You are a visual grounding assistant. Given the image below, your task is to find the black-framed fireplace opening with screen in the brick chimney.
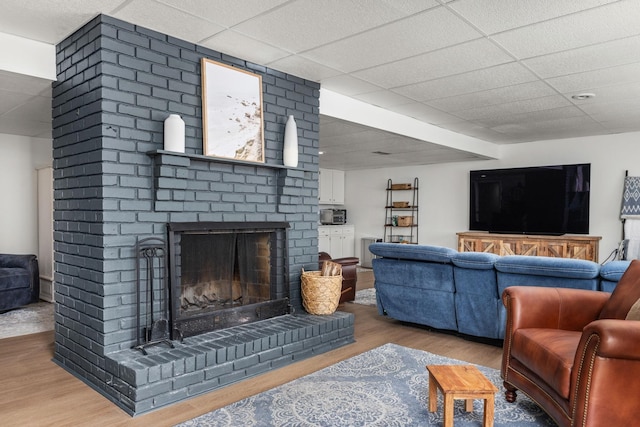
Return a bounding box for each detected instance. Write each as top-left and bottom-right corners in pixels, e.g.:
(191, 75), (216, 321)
(168, 222), (289, 339)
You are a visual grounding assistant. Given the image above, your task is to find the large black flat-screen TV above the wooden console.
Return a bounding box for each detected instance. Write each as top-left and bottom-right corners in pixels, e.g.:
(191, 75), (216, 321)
(469, 164), (591, 235)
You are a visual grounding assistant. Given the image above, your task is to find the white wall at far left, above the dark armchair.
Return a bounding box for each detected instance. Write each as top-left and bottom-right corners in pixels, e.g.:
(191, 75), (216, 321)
(0, 134), (52, 254)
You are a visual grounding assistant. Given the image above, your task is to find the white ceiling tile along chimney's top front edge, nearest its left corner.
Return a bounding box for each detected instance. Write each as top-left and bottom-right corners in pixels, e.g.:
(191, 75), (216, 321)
(113, 0), (224, 43)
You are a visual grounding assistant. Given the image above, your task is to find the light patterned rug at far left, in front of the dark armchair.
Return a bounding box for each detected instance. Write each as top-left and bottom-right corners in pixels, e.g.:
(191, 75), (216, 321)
(0, 301), (54, 338)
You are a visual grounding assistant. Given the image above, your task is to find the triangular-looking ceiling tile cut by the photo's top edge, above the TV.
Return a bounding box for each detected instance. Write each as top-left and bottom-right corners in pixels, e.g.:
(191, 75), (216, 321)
(451, 0), (617, 34)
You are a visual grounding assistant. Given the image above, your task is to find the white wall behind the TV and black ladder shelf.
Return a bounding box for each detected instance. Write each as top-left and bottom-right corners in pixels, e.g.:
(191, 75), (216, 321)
(345, 132), (640, 262)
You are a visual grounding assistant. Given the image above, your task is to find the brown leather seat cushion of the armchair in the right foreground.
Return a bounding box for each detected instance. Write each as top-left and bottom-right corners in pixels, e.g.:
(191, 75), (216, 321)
(511, 328), (582, 399)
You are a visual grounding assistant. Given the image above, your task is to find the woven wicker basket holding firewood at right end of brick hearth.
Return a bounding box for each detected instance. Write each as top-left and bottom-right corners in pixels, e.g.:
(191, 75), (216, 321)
(300, 271), (342, 314)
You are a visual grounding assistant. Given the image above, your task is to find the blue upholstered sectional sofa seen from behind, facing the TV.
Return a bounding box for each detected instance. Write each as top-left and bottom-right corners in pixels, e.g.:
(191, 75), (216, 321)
(369, 243), (629, 339)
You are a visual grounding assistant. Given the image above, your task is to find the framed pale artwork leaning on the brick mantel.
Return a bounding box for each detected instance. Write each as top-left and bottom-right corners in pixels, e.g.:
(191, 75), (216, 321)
(201, 58), (264, 163)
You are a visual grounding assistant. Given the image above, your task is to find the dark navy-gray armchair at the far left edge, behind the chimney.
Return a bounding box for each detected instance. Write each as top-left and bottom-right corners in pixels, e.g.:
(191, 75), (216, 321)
(0, 254), (40, 312)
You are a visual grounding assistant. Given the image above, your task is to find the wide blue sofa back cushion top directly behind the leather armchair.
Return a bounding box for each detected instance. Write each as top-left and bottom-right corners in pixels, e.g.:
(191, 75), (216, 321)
(495, 255), (600, 279)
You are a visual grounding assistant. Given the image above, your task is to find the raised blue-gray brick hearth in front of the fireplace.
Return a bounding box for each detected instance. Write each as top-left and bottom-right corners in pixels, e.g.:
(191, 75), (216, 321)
(107, 312), (354, 413)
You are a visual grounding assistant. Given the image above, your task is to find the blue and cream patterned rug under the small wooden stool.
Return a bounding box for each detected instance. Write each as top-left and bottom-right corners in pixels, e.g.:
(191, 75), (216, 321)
(179, 344), (555, 427)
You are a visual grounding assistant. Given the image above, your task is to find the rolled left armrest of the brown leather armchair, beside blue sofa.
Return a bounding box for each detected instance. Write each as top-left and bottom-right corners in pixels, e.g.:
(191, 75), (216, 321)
(502, 286), (610, 334)
